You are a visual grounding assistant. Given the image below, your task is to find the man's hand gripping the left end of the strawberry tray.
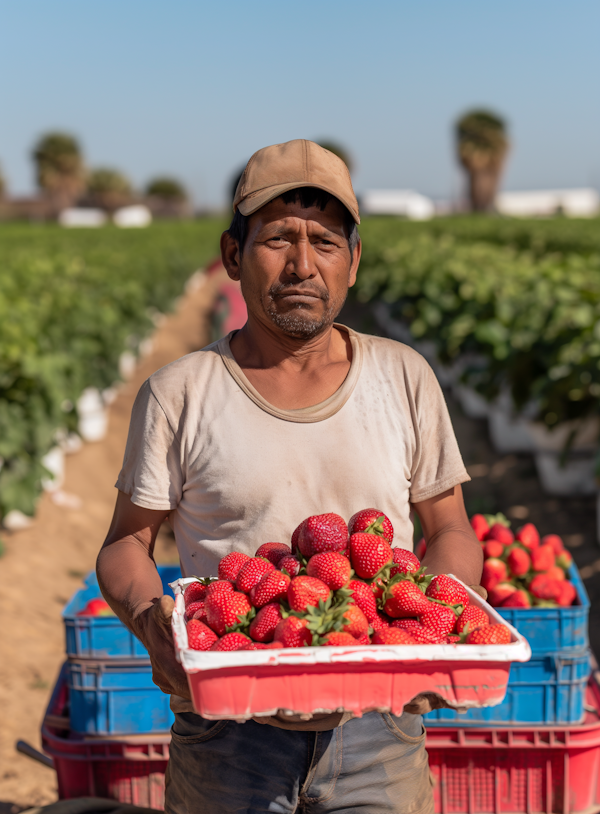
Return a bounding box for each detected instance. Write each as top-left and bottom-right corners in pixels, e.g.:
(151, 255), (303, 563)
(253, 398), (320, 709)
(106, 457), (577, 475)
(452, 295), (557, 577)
(136, 596), (191, 700)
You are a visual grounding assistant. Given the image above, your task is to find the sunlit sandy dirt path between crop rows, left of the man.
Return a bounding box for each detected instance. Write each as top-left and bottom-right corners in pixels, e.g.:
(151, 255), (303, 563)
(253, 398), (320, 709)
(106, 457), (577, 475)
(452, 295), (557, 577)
(0, 275), (219, 814)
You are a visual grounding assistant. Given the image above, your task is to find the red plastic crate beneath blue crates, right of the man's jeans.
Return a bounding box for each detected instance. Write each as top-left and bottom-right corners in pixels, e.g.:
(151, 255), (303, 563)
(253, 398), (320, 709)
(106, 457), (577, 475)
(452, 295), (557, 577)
(427, 679), (600, 814)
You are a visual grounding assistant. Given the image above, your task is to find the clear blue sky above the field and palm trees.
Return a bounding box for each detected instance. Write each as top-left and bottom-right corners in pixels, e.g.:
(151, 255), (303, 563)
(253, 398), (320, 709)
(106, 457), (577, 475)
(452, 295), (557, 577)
(0, 0), (600, 206)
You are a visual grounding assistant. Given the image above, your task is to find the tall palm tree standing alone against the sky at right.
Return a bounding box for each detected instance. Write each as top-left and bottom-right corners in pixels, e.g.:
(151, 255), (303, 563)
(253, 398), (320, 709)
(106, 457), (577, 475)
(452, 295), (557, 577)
(456, 110), (510, 212)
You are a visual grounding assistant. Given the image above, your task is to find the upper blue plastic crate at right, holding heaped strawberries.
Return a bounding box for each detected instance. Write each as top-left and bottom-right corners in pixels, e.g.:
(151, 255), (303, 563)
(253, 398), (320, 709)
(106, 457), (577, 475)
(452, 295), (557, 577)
(496, 564), (590, 653)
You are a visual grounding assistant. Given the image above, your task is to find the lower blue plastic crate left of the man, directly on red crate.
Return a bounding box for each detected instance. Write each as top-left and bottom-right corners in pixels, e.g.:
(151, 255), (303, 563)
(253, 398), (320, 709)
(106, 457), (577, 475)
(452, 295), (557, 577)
(68, 659), (174, 735)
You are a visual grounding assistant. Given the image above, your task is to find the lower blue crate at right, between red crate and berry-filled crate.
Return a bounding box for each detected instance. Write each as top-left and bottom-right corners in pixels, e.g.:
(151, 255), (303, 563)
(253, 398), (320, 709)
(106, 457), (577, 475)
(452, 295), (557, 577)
(424, 648), (591, 726)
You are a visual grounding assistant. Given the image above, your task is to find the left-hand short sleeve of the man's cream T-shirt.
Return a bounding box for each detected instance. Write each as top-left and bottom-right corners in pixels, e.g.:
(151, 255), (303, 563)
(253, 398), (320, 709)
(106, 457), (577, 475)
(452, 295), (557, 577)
(115, 381), (183, 510)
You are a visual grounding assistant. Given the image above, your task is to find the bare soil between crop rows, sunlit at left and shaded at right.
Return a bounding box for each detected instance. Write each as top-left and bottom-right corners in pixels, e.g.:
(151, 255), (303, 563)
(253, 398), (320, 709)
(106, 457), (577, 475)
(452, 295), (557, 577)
(0, 288), (600, 814)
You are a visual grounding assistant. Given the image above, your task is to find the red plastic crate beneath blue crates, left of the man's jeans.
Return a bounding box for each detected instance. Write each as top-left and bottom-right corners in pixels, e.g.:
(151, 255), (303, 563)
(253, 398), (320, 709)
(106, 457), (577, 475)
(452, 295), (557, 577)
(42, 667), (171, 810)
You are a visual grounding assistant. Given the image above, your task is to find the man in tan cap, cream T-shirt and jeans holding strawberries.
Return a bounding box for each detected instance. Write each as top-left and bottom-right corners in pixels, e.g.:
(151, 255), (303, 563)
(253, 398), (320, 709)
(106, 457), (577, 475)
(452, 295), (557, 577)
(98, 140), (482, 814)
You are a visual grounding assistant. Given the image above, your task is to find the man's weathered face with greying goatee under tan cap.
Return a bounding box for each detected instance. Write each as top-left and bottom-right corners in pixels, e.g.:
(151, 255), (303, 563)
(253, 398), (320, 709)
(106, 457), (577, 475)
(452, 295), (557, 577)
(223, 198), (360, 339)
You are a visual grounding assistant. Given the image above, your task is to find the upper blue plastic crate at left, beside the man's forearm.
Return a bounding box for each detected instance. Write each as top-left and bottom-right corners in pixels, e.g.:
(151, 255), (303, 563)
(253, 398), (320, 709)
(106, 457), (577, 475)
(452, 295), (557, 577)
(62, 565), (181, 660)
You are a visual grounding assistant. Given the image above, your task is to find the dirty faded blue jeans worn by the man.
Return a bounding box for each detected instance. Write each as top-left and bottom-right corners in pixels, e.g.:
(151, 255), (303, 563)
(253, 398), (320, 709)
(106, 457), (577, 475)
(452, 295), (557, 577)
(165, 712), (433, 814)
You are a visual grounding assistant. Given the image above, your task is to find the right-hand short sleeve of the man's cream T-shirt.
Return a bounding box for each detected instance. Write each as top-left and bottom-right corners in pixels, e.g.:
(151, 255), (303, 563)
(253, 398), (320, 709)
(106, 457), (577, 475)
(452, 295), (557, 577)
(410, 365), (471, 503)
